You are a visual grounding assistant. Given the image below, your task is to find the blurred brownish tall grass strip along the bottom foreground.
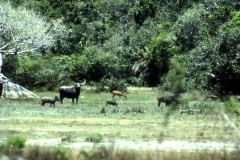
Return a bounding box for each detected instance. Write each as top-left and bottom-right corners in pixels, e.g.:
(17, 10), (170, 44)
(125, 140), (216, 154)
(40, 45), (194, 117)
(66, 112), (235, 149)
(0, 144), (239, 160)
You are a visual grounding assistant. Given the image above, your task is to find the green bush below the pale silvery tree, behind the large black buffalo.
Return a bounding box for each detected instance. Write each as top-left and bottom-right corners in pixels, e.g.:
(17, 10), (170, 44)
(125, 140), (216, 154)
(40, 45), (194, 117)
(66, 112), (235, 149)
(3, 53), (71, 91)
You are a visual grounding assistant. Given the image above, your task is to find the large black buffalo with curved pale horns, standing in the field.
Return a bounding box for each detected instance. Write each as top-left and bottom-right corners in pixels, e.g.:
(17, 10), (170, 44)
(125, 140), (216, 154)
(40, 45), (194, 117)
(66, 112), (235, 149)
(59, 79), (86, 104)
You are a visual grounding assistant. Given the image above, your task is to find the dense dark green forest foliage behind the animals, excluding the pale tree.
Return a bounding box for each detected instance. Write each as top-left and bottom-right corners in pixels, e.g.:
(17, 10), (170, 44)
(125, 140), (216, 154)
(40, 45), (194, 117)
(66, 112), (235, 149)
(2, 0), (240, 93)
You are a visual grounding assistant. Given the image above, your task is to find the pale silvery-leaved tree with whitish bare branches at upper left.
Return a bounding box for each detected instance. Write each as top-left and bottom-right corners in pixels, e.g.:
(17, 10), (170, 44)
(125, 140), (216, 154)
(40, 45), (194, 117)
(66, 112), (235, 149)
(0, 2), (67, 72)
